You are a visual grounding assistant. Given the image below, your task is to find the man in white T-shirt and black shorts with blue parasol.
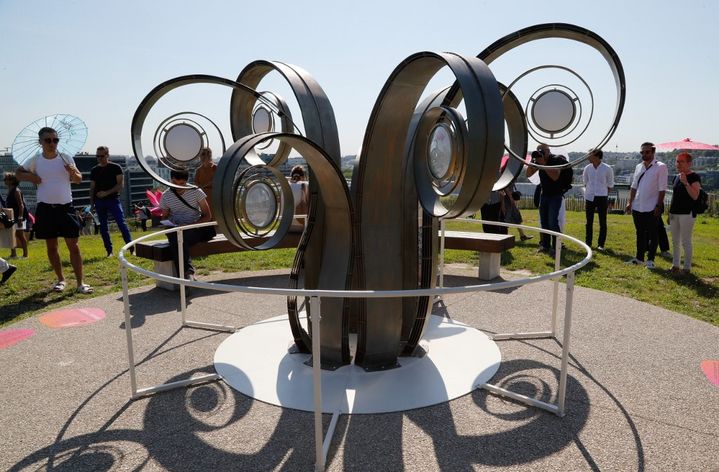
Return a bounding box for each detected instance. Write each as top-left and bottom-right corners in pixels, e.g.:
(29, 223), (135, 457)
(15, 127), (93, 294)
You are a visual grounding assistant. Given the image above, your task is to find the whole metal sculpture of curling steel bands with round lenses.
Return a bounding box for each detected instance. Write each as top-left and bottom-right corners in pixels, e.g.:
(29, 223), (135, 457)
(132, 23), (625, 370)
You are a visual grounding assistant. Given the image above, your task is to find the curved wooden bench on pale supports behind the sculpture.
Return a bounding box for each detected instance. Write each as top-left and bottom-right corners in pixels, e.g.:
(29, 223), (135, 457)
(135, 231), (515, 290)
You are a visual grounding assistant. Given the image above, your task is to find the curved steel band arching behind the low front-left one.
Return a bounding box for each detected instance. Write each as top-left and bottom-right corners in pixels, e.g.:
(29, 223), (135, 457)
(230, 60), (349, 363)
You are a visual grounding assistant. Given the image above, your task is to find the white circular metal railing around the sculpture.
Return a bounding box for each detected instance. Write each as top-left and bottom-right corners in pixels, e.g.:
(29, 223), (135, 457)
(118, 218), (592, 471)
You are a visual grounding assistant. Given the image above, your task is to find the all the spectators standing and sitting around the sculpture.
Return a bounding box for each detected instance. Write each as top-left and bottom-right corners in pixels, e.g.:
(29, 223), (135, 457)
(0, 127), (701, 294)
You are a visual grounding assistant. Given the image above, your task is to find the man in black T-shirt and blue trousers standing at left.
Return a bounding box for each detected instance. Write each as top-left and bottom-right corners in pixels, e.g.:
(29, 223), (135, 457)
(90, 146), (132, 257)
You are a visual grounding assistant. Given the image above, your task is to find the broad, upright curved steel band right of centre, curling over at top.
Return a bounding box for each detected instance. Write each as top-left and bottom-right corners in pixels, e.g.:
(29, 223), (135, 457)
(353, 52), (504, 369)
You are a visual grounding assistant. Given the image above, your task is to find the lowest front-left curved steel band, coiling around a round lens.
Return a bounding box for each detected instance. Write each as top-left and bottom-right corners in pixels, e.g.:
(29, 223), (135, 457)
(212, 133), (353, 368)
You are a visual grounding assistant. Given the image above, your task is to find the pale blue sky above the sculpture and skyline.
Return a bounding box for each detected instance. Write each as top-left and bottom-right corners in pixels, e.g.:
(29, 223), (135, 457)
(0, 0), (719, 155)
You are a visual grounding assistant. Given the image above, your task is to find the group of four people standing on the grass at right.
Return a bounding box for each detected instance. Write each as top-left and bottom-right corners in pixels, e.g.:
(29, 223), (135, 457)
(527, 142), (701, 274)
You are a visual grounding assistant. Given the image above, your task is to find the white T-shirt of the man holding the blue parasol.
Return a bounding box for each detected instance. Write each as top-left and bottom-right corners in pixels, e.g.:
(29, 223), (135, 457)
(23, 153), (75, 205)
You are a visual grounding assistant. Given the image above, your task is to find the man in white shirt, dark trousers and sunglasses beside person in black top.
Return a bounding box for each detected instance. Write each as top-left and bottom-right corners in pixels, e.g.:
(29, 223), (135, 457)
(625, 142), (669, 269)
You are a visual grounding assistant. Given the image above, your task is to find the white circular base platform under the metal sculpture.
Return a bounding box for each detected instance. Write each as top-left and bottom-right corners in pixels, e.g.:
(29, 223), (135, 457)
(215, 315), (501, 413)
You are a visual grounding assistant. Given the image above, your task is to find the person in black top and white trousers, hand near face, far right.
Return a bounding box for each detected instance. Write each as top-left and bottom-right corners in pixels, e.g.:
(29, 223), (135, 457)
(669, 152), (702, 274)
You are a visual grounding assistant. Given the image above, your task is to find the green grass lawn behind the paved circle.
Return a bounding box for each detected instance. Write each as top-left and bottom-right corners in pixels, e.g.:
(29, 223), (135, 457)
(0, 210), (719, 326)
